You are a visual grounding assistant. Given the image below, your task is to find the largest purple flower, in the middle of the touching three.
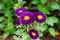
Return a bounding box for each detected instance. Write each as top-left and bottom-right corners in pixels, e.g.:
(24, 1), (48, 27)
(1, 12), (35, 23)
(19, 12), (34, 25)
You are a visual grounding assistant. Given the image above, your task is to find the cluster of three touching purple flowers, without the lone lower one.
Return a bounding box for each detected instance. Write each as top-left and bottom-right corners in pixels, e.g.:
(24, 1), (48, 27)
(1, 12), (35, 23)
(15, 8), (46, 25)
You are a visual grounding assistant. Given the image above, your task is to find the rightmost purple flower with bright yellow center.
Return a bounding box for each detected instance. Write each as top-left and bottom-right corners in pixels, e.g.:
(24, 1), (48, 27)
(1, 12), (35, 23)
(34, 12), (46, 23)
